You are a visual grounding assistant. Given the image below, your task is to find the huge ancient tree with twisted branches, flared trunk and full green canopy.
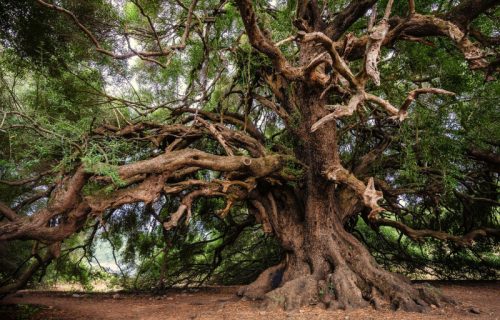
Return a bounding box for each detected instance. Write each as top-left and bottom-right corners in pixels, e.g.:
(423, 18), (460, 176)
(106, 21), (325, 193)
(0, 0), (500, 310)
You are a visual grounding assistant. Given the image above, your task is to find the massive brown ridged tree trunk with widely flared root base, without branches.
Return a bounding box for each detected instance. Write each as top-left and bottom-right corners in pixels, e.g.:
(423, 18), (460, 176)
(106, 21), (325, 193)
(239, 82), (452, 311)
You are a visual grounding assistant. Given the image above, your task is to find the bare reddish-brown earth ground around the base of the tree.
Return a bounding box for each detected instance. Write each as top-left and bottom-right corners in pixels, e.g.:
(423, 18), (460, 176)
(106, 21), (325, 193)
(0, 281), (500, 320)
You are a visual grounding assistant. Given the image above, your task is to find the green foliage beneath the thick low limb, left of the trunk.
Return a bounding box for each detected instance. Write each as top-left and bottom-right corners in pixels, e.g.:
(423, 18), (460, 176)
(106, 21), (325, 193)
(81, 199), (281, 290)
